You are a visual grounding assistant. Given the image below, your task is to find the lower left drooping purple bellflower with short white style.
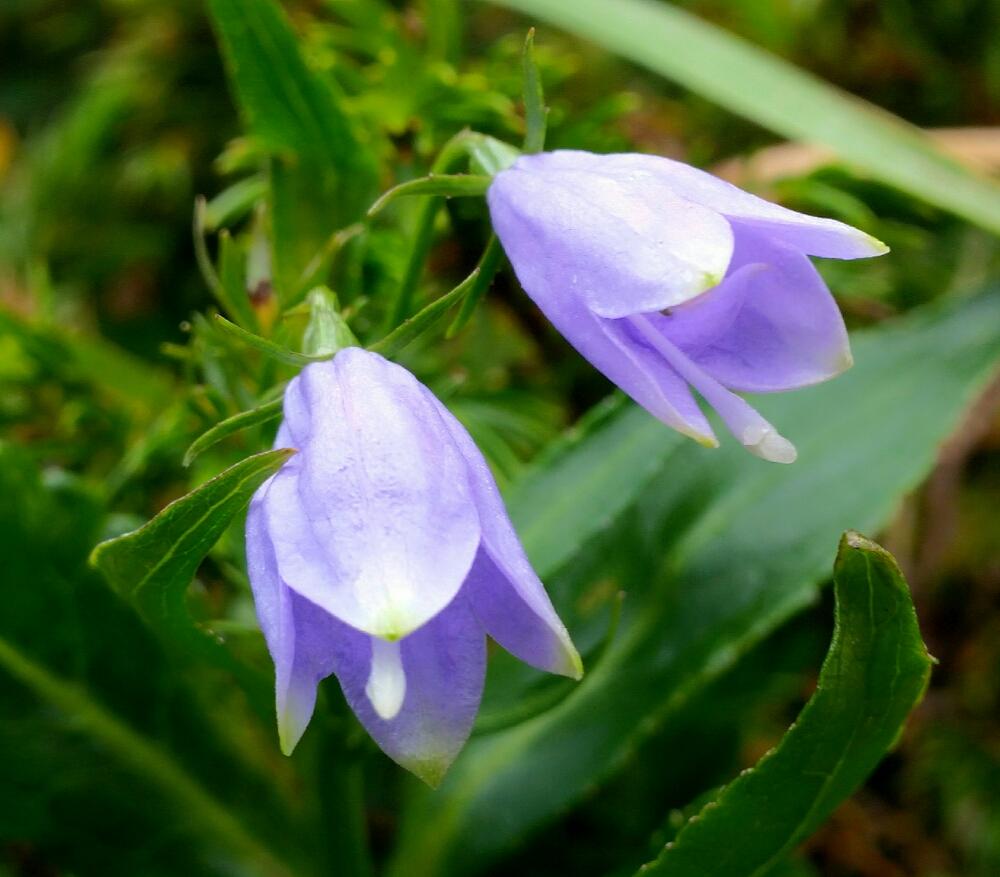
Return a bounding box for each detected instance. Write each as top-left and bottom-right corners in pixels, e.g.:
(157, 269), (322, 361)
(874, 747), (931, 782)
(246, 348), (582, 784)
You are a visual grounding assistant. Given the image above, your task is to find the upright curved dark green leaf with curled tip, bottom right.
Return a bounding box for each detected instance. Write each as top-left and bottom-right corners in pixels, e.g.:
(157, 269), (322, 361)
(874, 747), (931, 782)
(639, 533), (931, 877)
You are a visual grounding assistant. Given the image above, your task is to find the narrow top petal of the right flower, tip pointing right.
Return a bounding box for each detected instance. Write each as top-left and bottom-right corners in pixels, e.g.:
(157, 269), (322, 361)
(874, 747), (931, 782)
(528, 150), (888, 258)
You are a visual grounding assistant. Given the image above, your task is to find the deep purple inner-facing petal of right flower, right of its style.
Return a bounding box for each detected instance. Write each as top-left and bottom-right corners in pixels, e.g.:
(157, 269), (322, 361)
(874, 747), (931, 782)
(648, 224), (851, 393)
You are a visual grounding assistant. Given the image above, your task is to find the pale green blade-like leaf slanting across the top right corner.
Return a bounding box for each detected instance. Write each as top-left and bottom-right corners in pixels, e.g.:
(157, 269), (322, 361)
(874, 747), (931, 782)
(491, 0), (1000, 233)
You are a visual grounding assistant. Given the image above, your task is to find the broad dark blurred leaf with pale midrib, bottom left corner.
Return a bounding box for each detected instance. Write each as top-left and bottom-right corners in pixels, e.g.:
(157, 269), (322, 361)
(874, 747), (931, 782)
(0, 441), (309, 877)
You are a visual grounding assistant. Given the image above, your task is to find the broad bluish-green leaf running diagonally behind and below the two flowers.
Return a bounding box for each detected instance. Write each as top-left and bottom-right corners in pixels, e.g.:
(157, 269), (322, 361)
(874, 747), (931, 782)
(394, 292), (1000, 875)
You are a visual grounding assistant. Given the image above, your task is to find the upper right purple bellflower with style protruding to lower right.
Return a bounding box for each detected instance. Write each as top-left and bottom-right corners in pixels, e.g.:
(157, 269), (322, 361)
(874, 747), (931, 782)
(487, 151), (887, 463)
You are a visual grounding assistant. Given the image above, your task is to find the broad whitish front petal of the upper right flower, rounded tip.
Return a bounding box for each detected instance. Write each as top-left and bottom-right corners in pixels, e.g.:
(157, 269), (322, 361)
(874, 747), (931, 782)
(487, 153), (733, 317)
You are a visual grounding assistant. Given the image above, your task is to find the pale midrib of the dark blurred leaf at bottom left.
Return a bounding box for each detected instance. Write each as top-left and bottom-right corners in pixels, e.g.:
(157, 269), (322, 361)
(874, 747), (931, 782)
(0, 638), (292, 877)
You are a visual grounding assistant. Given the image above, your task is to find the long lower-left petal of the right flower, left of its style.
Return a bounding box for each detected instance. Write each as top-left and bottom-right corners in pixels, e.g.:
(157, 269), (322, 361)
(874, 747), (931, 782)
(491, 183), (717, 446)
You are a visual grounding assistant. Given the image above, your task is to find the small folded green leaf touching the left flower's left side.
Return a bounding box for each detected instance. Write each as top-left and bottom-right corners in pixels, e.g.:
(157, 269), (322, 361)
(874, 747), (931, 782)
(90, 450), (295, 639)
